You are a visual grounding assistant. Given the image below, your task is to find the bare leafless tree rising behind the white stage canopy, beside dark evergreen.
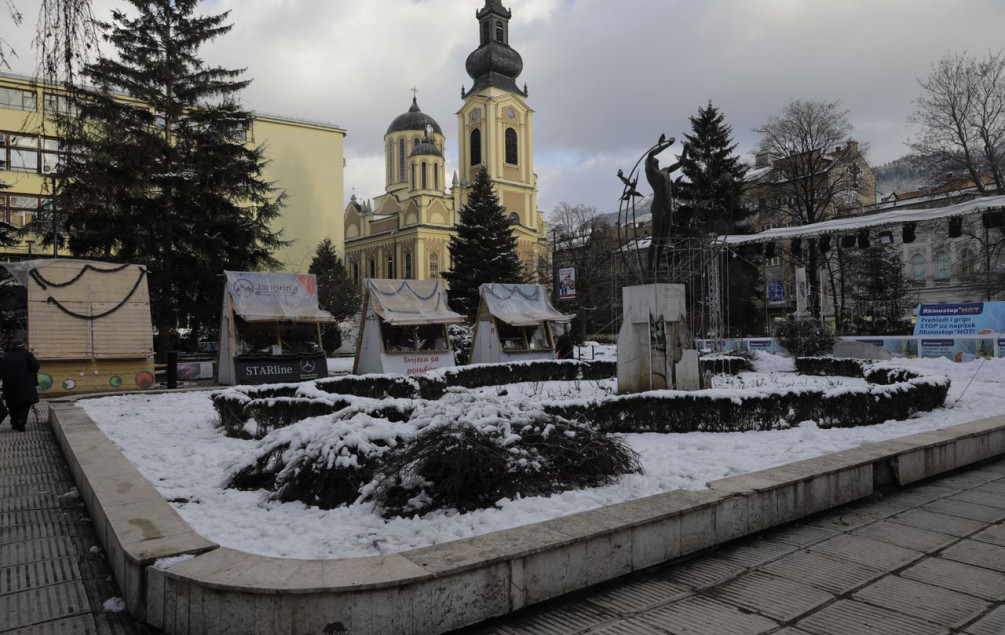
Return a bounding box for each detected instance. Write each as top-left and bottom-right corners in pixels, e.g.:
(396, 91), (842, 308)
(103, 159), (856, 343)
(754, 99), (862, 318)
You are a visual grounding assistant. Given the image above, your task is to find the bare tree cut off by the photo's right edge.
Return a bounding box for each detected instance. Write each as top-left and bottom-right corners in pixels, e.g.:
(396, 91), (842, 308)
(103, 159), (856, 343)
(908, 51), (1005, 194)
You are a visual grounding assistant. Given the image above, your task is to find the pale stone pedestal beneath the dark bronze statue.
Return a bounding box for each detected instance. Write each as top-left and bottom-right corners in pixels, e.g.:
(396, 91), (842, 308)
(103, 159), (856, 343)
(618, 283), (701, 394)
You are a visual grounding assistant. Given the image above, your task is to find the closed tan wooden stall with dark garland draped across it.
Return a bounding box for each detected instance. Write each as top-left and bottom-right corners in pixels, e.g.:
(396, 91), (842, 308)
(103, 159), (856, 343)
(0, 258), (154, 396)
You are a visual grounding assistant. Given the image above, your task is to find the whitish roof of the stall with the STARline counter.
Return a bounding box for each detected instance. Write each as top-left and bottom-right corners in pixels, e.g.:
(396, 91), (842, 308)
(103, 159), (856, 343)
(224, 271), (335, 322)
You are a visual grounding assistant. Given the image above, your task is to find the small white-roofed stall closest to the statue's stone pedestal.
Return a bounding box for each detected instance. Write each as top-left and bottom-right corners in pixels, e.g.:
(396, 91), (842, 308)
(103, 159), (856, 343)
(471, 284), (575, 364)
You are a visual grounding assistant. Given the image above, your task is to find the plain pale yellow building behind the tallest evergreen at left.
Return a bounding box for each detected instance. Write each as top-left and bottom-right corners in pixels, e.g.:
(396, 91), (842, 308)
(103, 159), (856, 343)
(0, 73), (346, 271)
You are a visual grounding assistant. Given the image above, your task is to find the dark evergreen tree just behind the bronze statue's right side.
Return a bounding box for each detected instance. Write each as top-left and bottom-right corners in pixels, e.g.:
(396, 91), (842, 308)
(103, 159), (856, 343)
(677, 101), (747, 234)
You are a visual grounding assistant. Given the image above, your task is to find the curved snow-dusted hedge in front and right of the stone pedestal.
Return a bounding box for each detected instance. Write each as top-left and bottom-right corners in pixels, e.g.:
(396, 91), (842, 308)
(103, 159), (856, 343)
(546, 360), (950, 433)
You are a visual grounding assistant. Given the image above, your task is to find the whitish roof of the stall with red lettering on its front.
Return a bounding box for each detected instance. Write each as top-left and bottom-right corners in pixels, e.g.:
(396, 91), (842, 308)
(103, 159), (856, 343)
(366, 278), (464, 326)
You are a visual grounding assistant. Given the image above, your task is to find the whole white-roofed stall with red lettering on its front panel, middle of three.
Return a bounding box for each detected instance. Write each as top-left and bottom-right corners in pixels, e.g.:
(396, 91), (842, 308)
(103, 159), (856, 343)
(353, 279), (464, 375)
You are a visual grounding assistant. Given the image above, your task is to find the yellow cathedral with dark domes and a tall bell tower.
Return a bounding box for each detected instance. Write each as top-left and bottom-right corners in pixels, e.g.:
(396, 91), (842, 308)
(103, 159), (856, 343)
(345, 0), (548, 285)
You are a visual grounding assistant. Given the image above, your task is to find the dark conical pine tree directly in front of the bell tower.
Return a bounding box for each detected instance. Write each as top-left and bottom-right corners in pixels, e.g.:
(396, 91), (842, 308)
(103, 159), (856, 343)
(443, 170), (524, 320)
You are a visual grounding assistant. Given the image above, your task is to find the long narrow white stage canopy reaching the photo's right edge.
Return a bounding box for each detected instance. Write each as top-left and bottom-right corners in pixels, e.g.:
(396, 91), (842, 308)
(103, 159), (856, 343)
(725, 196), (1005, 245)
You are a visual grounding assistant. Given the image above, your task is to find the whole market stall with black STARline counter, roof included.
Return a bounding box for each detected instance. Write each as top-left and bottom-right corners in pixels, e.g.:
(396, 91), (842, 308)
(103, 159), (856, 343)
(217, 271), (335, 385)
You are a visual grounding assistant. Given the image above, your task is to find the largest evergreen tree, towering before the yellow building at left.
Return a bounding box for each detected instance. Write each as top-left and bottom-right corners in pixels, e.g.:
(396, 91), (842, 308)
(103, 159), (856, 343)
(56, 0), (286, 355)
